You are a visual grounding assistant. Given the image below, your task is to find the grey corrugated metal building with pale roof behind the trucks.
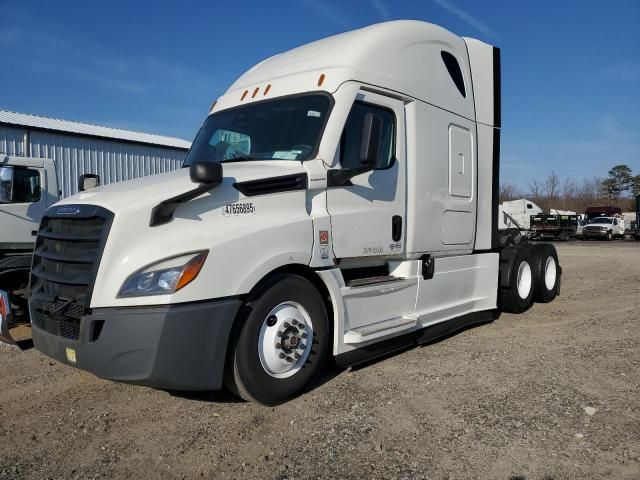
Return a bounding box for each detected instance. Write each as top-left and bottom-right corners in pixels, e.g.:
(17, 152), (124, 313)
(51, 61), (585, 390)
(0, 110), (191, 197)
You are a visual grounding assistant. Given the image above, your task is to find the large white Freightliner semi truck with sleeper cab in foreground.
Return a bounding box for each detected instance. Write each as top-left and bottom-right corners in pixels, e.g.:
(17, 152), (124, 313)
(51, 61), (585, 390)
(30, 21), (561, 405)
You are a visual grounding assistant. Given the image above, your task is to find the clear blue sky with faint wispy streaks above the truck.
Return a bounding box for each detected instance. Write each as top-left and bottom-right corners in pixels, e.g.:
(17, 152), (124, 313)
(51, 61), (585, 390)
(0, 0), (640, 189)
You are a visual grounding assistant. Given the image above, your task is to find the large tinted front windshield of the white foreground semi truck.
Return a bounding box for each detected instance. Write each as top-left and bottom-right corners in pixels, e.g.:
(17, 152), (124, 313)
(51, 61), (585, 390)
(184, 93), (331, 166)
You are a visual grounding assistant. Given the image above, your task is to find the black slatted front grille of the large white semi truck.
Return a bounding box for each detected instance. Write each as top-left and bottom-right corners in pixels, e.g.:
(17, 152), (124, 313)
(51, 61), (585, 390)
(29, 205), (113, 340)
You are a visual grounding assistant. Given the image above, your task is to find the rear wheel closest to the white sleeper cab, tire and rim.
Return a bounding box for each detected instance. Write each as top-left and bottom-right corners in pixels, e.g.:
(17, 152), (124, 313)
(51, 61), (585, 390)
(498, 245), (535, 313)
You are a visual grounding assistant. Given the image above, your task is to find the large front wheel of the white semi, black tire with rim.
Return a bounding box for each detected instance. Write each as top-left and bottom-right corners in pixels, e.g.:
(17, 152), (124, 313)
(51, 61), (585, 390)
(225, 274), (329, 405)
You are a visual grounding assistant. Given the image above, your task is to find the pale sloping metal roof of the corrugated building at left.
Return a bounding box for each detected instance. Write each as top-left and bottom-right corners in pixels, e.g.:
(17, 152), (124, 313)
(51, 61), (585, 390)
(0, 110), (191, 150)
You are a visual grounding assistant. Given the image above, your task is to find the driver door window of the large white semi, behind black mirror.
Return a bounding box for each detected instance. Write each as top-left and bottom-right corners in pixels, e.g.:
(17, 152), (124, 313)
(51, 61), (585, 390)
(340, 102), (395, 170)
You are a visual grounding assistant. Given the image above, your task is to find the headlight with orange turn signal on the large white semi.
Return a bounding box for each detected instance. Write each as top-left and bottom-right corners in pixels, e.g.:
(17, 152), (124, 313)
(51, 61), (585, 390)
(118, 252), (208, 297)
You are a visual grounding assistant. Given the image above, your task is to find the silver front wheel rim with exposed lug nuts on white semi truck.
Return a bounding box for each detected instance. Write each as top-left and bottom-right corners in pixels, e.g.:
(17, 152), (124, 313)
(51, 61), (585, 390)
(258, 301), (313, 378)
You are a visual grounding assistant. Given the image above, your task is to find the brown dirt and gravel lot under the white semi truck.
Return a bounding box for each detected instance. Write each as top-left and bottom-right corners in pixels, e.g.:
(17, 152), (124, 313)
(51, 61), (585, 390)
(0, 242), (640, 480)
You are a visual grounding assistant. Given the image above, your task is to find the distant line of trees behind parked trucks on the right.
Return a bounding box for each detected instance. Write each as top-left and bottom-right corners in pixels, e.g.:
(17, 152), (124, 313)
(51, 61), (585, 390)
(500, 165), (640, 213)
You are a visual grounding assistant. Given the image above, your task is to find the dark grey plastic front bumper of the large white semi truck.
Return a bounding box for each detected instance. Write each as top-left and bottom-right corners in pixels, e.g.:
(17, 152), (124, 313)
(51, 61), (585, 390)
(32, 298), (241, 390)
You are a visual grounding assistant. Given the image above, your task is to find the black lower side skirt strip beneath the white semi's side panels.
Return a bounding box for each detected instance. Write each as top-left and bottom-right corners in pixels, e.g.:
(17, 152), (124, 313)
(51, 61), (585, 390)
(335, 310), (499, 367)
